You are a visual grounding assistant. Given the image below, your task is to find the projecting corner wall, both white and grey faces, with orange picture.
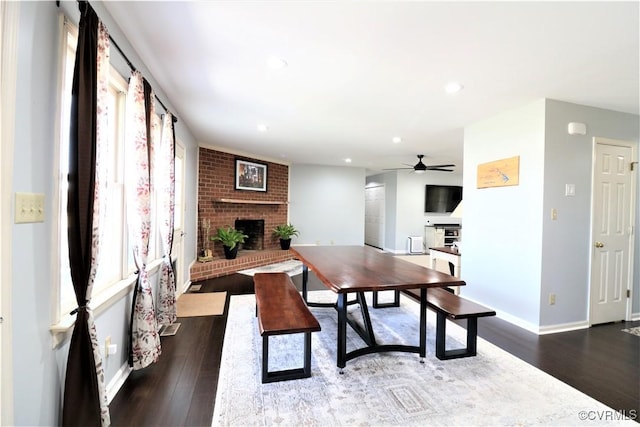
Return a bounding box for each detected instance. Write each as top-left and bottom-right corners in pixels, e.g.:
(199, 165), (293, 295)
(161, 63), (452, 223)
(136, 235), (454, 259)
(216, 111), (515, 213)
(462, 100), (640, 332)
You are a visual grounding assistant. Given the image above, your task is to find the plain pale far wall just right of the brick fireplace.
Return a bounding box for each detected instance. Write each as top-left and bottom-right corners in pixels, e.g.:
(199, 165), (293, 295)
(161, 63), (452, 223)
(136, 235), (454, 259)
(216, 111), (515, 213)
(289, 164), (365, 245)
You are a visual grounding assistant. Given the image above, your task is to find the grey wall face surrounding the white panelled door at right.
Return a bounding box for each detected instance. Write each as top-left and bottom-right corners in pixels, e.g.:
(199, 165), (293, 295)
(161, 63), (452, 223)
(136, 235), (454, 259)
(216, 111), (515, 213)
(540, 100), (640, 326)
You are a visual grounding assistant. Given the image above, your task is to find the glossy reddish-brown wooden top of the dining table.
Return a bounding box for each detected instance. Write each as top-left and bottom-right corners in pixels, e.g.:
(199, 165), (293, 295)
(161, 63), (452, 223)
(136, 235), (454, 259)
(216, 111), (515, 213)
(291, 246), (465, 293)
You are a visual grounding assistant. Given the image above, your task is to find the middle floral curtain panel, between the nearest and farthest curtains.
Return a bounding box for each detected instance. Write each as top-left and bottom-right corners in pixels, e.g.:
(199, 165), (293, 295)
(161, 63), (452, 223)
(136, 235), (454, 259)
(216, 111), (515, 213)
(125, 71), (161, 369)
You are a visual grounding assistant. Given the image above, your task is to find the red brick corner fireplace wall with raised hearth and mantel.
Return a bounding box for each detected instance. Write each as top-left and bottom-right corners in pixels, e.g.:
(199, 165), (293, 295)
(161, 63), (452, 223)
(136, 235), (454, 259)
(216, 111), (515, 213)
(191, 147), (292, 281)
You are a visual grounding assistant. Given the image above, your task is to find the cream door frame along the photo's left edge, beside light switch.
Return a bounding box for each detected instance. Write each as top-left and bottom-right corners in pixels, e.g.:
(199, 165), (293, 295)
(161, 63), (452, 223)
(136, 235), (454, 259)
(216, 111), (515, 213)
(0, 2), (20, 425)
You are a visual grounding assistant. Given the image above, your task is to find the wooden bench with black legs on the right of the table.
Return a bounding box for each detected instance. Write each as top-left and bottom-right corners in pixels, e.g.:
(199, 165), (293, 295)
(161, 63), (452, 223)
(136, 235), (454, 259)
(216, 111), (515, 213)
(405, 288), (496, 360)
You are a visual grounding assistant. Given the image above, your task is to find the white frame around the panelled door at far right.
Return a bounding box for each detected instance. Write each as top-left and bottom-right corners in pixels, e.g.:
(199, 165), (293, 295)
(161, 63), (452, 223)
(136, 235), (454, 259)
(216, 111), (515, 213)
(588, 137), (638, 326)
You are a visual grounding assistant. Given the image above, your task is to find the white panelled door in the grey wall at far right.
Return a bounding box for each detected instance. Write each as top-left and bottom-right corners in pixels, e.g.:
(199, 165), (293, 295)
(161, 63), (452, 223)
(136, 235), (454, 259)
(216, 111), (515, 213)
(589, 138), (634, 325)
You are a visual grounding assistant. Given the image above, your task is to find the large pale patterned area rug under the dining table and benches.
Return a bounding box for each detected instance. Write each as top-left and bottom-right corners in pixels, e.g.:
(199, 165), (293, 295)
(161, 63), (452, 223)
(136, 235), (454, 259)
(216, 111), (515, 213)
(212, 291), (636, 426)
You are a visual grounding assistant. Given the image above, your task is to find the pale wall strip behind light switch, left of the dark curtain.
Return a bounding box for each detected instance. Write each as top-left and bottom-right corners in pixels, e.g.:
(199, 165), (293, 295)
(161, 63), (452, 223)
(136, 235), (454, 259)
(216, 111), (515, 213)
(11, 2), (62, 425)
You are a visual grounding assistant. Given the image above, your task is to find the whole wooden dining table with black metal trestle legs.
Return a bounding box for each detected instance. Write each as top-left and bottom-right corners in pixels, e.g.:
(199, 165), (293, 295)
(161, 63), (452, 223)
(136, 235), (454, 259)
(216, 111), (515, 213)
(290, 246), (465, 373)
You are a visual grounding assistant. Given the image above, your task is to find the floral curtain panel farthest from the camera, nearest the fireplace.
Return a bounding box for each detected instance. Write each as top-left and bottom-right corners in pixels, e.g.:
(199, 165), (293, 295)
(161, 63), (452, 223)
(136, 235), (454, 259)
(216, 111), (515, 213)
(156, 111), (177, 325)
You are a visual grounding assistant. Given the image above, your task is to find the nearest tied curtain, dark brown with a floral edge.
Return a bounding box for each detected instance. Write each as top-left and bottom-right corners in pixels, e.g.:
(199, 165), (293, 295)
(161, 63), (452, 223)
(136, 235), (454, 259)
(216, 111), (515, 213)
(62, 2), (111, 426)
